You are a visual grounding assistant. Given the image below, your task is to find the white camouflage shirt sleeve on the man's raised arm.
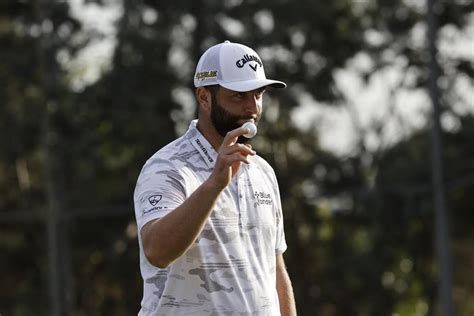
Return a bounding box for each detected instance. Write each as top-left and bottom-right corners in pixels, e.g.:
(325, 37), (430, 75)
(134, 159), (186, 231)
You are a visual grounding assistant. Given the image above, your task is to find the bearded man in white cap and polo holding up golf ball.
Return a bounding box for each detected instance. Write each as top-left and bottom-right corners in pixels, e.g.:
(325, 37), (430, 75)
(134, 41), (296, 316)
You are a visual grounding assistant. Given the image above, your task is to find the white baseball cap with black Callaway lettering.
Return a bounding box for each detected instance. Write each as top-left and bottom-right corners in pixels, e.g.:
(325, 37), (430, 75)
(194, 41), (286, 92)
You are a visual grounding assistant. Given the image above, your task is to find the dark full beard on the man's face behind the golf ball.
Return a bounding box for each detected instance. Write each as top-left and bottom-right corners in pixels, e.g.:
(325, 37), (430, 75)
(211, 95), (258, 144)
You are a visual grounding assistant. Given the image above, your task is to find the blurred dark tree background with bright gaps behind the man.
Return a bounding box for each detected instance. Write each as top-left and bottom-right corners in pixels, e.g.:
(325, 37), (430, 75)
(0, 0), (474, 316)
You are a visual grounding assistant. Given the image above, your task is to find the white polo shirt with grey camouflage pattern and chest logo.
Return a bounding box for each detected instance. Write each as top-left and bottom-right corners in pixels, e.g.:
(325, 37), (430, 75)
(134, 120), (287, 316)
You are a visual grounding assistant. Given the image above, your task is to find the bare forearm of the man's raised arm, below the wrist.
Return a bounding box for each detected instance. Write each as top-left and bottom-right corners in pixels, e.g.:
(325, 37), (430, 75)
(141, 181), (221, 268)
